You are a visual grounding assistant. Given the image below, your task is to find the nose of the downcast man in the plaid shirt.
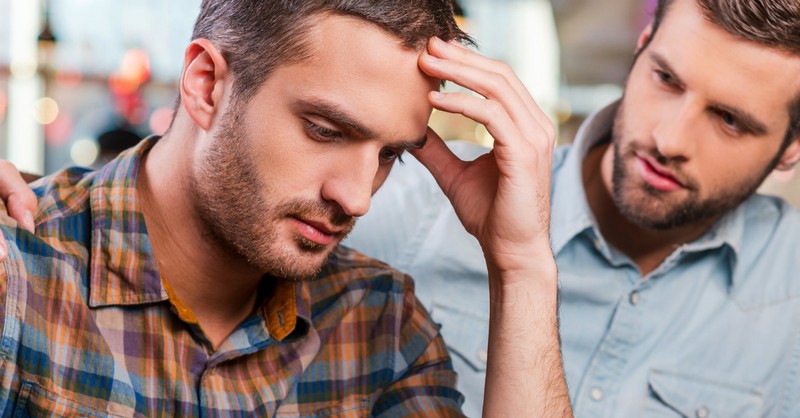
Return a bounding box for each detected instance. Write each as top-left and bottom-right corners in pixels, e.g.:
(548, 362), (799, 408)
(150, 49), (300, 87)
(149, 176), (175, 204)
(322, 147), (380, 217)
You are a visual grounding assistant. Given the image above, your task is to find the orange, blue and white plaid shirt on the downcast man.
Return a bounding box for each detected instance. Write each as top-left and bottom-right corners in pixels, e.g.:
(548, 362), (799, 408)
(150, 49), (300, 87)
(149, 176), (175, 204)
(0, 138), (462, 417)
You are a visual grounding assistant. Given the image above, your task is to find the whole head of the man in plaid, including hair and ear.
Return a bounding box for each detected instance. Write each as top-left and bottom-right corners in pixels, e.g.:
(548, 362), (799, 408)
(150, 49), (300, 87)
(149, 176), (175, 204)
(176, 0), (466, 279)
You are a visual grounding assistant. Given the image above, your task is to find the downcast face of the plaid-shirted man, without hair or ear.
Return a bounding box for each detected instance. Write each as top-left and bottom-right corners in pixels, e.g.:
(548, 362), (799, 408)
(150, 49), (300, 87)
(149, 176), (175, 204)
(192, 16), (438, 279)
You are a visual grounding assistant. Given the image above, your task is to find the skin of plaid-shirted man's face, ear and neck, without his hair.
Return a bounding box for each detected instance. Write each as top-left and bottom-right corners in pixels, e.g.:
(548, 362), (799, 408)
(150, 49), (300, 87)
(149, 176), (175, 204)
(139, 17), (438, 346)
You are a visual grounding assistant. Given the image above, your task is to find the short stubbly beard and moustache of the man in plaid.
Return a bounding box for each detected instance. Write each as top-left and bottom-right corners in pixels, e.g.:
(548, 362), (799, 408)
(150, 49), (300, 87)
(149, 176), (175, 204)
(189, 105), (355, 281)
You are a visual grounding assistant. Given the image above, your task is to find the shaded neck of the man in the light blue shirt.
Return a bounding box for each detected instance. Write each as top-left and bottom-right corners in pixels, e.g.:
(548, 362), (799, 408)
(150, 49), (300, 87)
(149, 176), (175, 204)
(583, 145), (716, 277)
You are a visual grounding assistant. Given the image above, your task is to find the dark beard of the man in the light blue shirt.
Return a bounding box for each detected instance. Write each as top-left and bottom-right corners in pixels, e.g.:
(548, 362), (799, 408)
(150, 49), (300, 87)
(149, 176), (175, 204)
(611, 99), (783, 231)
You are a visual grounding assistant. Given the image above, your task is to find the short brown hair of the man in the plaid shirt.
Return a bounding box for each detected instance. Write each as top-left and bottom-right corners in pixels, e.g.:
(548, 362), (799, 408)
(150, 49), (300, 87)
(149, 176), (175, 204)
(192, 0), (472, 102)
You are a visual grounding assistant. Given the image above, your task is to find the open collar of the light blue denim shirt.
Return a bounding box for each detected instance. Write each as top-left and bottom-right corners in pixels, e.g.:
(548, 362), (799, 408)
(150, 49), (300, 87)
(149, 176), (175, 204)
(550, 101), (746, 284)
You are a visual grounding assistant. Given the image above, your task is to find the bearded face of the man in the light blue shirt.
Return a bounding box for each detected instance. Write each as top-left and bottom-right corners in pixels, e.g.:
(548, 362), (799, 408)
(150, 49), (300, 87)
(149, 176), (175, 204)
(603, 0), (800, 230)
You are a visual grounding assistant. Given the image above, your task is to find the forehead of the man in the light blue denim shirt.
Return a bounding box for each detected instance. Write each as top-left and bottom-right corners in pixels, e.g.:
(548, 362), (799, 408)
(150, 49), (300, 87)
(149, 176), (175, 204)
(645, 0), (800, 124)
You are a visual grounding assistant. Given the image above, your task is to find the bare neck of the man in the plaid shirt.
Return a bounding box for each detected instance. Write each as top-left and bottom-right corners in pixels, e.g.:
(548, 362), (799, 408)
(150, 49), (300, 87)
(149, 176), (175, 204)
(137, 129), (262, 347)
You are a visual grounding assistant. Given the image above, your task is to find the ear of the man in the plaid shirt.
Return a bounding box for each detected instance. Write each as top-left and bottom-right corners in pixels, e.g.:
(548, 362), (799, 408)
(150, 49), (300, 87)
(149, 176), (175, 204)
(180, 39), (229, 131)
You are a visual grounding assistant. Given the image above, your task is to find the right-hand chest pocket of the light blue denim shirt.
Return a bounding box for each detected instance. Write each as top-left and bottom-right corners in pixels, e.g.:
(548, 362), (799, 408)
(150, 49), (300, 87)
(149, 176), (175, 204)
(642, 370), (763, 418)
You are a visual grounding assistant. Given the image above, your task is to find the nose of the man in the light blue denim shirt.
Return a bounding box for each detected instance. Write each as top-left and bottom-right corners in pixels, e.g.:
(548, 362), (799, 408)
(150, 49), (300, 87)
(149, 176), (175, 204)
(653, 100), (701, 160)
